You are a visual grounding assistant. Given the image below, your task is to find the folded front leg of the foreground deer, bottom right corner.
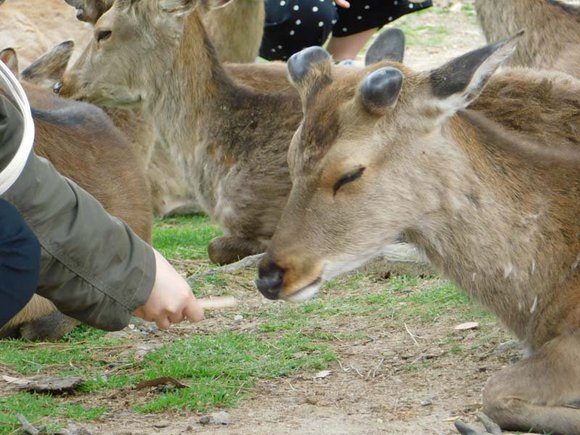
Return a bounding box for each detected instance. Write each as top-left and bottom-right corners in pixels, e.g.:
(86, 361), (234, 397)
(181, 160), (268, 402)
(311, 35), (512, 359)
(483, 331), (580, 435)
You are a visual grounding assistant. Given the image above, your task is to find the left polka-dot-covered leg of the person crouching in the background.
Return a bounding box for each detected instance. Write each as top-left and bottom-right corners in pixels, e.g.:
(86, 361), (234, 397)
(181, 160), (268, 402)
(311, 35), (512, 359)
(260, 0), (337, 60)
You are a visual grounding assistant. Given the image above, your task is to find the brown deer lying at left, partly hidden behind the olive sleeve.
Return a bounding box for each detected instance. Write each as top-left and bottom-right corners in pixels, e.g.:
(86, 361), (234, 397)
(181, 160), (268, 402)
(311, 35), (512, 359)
(0, 50), (152, 340)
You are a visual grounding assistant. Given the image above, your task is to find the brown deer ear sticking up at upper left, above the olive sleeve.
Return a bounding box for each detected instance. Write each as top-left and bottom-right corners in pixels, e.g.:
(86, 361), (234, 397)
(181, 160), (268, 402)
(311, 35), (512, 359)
(21, 41), (75, 83)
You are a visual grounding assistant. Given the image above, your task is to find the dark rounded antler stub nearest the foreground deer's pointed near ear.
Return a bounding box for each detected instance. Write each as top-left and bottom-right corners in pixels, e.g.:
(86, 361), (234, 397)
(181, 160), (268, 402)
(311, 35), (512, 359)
(358, 67), (403, 116)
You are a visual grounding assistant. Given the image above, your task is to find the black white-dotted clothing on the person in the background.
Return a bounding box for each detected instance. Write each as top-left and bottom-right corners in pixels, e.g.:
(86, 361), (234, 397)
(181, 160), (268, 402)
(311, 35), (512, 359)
(260, 0), (432, 60)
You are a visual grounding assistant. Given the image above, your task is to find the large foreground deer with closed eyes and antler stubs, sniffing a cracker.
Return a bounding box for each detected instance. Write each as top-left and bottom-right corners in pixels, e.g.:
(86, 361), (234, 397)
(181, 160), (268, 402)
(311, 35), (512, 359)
(256, 37), (580, 434)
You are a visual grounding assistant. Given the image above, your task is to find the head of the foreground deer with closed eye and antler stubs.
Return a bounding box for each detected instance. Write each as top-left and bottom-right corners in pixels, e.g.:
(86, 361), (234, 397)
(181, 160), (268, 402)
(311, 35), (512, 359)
(257, 33), (516, 302)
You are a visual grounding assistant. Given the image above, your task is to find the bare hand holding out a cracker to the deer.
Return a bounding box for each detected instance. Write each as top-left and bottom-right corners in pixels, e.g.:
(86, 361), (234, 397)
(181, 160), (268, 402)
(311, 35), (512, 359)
(134, 249), (203, 329)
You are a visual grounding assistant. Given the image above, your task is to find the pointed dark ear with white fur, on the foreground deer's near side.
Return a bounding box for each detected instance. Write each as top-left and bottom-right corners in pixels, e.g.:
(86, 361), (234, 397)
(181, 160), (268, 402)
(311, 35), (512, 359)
(429, 30), (524, 113)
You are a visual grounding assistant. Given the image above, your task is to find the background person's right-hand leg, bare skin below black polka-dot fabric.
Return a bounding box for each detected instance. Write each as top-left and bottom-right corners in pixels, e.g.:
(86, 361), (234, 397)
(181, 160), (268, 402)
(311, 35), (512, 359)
(328, 0), (432, 62)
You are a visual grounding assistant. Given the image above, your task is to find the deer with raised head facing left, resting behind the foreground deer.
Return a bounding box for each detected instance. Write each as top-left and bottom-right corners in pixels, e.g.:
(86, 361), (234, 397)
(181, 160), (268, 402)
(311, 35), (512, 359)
(56, 0), (404, 264)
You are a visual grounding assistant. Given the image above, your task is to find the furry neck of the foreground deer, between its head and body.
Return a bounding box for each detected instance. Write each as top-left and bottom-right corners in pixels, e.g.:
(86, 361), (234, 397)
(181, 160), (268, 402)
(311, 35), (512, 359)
(407, 114), (576, 343)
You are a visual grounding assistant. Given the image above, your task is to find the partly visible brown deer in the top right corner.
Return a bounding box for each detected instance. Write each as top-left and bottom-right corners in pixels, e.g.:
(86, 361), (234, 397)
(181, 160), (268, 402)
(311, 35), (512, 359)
(475, 0), (580, 78)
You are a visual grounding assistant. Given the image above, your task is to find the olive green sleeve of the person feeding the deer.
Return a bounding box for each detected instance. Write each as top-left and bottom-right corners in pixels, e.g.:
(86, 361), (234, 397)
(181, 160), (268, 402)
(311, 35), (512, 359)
(2, 153), (155, 330)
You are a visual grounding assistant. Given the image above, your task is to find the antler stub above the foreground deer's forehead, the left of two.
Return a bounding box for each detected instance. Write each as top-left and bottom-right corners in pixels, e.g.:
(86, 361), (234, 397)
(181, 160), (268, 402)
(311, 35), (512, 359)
(288, 47), (332, 102)
